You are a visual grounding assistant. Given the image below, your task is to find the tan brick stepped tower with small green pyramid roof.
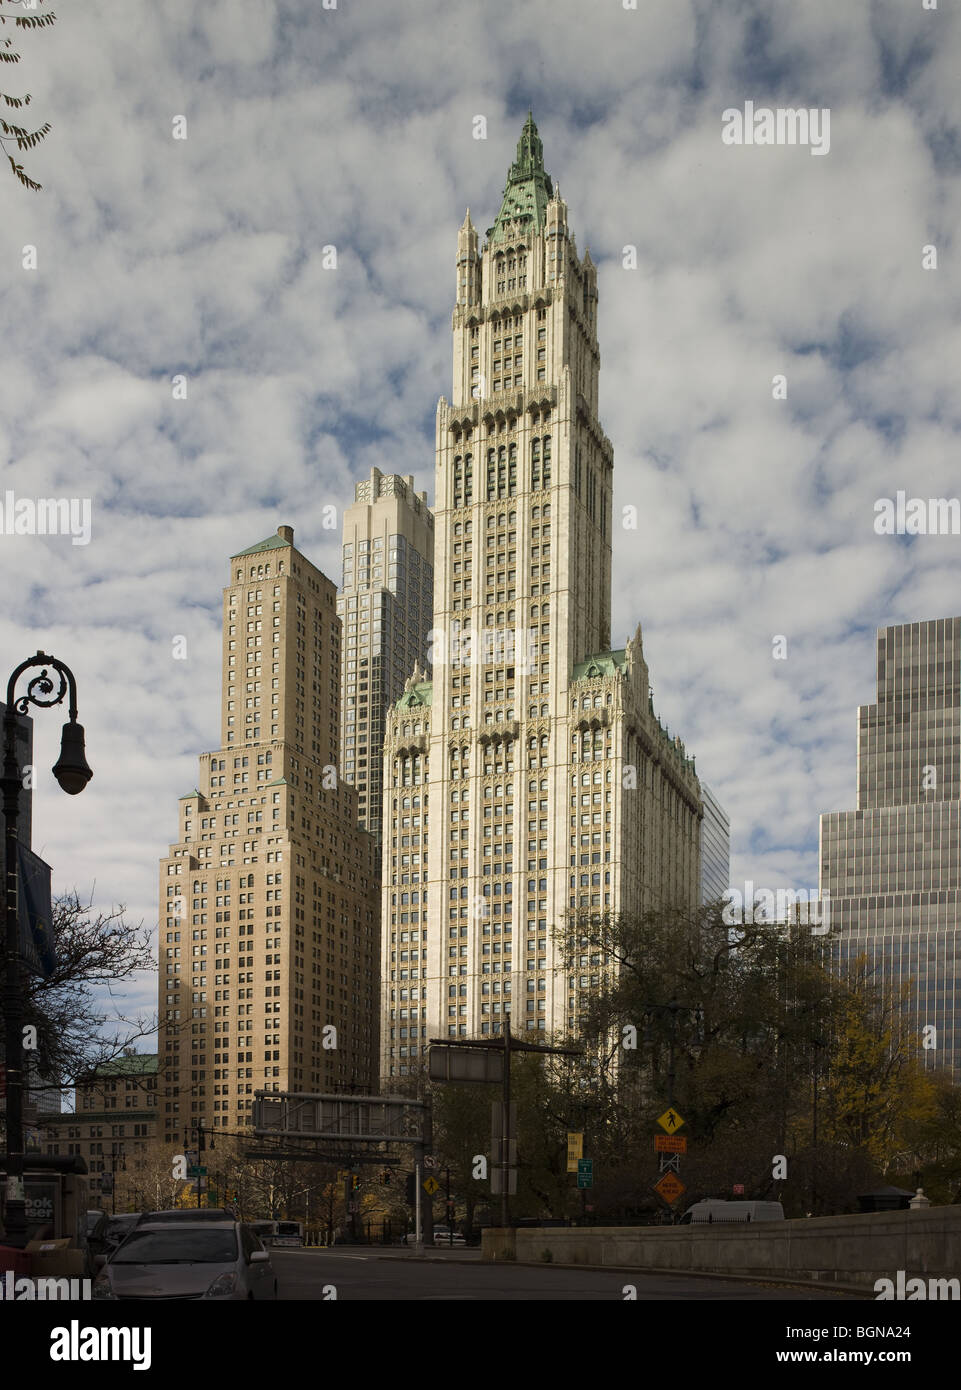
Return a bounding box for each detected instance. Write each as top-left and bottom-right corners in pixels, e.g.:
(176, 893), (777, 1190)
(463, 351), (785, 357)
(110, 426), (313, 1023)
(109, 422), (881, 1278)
(160, 525), (380, 1144)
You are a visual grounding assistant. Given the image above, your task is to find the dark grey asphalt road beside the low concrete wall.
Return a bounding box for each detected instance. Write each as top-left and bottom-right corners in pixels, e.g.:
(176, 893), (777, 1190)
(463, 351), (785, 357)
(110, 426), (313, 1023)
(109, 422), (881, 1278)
(270, 1247), (854, 1302)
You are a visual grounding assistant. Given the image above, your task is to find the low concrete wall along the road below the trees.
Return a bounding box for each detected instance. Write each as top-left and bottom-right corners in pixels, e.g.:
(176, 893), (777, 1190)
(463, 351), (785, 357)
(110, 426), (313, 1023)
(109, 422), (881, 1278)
(483, 1207), (961, 1291)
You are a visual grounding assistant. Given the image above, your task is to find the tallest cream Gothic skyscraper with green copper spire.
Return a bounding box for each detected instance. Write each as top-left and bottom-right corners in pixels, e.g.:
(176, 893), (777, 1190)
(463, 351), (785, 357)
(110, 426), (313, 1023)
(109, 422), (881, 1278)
(381, 115), (702, 1079)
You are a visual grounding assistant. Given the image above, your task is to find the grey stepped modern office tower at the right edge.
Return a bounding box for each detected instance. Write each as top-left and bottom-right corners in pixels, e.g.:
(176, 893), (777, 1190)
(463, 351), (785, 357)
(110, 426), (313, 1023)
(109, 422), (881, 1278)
(821, 617), (961, 1068)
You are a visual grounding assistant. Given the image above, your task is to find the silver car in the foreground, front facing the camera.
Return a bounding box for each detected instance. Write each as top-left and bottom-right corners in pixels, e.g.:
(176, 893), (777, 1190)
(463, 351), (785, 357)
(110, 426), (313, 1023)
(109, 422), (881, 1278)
(93, 1222), (277, 1300)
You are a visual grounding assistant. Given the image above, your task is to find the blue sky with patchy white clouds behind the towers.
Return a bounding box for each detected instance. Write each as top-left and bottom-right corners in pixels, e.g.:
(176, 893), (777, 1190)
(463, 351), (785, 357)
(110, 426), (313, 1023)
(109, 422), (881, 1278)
(0, 0), (961, 1045)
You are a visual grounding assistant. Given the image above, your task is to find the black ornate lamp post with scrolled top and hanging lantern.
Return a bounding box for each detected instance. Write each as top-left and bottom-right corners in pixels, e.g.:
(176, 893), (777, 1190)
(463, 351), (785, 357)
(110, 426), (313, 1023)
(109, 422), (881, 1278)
(0, 652), (93, 1250)
